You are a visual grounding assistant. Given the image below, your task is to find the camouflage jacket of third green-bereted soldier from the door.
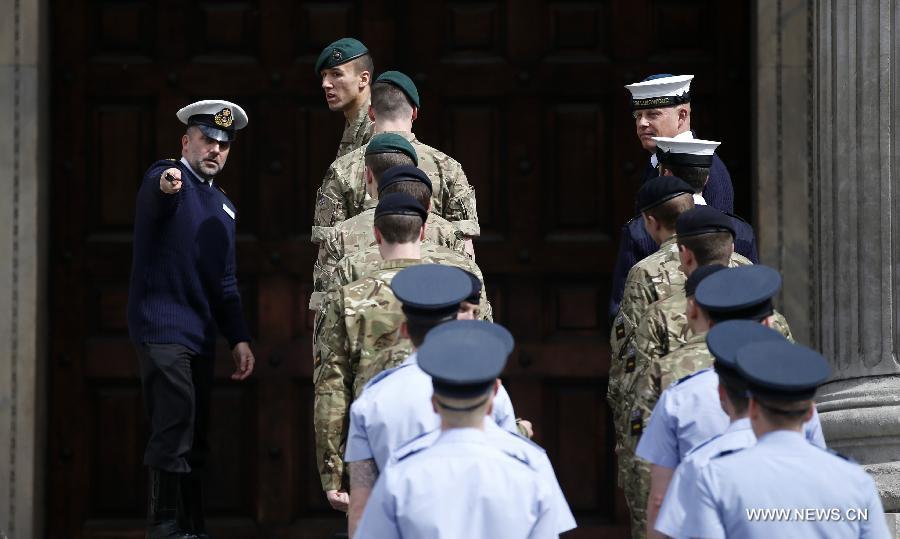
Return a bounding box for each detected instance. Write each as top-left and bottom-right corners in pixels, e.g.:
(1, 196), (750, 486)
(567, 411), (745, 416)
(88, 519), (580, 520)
(309, 208), (468, 310)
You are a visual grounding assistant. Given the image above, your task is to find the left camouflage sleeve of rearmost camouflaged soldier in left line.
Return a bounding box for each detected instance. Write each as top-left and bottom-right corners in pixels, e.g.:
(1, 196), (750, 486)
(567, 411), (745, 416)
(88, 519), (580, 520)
(313, 290), (353, 491)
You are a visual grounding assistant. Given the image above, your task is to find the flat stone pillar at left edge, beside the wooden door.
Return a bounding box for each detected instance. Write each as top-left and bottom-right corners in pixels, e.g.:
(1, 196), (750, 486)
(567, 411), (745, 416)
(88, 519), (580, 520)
(0, 0), (49, 539)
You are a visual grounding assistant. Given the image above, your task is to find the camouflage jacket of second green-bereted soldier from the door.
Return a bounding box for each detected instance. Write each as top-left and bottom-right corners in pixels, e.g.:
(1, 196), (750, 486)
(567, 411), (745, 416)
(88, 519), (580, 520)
(311, 132), (481, 243)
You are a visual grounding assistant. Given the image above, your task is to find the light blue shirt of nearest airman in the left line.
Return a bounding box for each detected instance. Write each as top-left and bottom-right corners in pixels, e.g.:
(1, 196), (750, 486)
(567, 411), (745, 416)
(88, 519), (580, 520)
(356, 429), (558, 539)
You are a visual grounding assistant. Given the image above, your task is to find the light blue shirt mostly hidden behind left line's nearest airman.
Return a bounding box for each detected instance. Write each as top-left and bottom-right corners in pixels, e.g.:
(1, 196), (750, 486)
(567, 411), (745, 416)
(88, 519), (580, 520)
(388, 419), (576, 533)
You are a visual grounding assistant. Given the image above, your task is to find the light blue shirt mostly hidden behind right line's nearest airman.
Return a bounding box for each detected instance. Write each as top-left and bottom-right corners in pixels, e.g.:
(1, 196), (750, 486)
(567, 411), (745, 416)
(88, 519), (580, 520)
(655, 417), (756, 539)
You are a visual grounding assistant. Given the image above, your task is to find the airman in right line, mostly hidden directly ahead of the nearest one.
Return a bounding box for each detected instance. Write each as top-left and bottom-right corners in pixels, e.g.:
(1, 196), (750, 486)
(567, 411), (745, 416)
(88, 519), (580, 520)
(655, 320), (784, 538)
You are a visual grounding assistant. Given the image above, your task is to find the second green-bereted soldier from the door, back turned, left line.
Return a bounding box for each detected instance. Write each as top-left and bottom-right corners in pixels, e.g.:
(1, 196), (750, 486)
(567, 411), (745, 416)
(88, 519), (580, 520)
(312, 71), (481, 252)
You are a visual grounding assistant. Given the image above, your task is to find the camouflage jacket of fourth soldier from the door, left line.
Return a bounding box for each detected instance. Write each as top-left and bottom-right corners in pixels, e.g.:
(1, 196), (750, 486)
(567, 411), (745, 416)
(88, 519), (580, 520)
(327, 242), (494, 321)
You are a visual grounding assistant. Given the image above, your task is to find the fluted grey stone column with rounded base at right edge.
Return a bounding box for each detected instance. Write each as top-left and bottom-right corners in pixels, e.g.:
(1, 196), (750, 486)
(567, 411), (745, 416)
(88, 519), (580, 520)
(812, 0), (900, 526)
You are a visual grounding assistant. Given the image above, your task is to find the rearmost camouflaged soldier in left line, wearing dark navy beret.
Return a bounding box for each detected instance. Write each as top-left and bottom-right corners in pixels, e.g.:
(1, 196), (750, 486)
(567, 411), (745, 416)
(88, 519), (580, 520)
(313, 193), (458, 511)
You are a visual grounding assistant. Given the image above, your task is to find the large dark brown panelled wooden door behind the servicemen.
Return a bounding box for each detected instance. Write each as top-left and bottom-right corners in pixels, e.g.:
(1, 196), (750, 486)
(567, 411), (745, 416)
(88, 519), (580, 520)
(47, 0), (750, 538)
